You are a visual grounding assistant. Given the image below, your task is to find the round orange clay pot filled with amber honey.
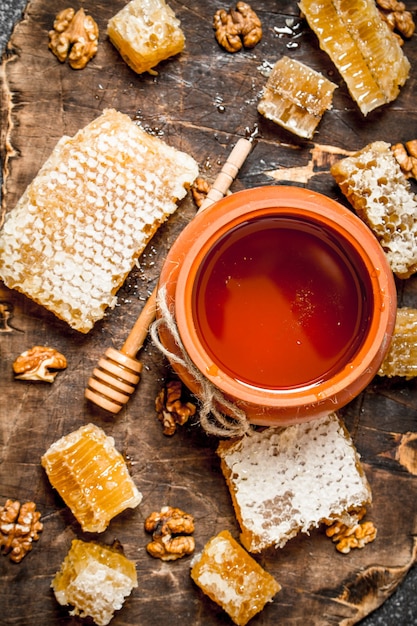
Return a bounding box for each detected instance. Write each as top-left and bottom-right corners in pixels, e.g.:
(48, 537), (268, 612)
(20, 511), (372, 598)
(159, 186), (397, 426)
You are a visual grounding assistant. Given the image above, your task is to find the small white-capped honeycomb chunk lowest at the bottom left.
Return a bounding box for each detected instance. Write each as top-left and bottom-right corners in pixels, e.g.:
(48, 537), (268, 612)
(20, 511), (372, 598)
(51, 539), (138, 626)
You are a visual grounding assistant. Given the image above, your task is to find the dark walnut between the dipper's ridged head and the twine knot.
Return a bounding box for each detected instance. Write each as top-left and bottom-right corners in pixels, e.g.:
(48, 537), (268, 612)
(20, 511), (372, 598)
(155, 380), (196, 436)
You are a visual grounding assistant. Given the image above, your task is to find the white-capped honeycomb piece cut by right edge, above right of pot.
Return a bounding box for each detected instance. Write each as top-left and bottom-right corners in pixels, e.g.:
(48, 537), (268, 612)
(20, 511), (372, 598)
(330, 141), (417, 279)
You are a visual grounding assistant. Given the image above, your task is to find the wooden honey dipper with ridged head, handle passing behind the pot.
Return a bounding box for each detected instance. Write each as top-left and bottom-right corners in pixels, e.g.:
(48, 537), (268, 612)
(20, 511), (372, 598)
(85, 136), (253, 414)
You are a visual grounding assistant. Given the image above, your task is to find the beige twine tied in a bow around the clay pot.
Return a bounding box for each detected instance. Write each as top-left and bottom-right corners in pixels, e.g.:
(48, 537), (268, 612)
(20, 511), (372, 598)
(150, 286), (250, 437)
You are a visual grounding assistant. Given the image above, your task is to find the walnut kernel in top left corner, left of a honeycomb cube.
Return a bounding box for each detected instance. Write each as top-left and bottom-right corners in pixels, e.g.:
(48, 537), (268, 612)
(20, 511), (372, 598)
(49, 8), (98, 70)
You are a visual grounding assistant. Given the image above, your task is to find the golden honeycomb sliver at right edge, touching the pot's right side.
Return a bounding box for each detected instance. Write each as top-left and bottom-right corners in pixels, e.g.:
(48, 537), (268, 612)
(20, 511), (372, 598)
(378, 307), (417, 380)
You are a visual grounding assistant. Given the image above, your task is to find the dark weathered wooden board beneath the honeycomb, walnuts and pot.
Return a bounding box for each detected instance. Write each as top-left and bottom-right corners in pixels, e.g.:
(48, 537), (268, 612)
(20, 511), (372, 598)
(0, 0), (417, 626)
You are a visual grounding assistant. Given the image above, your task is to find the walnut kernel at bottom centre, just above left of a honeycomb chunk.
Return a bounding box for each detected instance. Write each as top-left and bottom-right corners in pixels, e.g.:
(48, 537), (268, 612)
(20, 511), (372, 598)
(145, 506), (195, 561)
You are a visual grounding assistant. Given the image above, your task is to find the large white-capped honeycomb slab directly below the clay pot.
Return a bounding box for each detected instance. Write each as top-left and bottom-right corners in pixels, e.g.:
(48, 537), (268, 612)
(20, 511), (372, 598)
(217, 413), (372, 553)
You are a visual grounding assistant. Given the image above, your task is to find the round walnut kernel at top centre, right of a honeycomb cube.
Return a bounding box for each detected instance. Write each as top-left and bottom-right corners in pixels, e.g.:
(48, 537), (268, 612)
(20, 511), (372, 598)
(213, 2), (262, 52)
